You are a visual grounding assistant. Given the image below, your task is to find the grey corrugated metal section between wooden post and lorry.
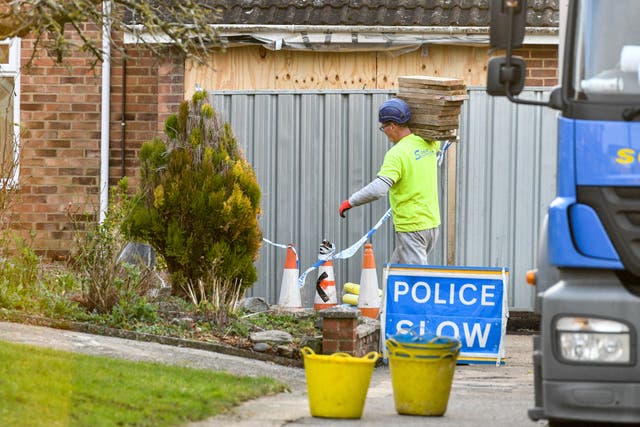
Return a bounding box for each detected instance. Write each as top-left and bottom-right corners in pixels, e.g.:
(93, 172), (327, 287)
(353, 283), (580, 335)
(456, 88), (557, 310)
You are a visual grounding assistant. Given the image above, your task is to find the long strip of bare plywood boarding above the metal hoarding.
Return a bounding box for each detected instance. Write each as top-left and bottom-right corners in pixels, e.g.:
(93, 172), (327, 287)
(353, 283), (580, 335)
(185, 45), (488, 93)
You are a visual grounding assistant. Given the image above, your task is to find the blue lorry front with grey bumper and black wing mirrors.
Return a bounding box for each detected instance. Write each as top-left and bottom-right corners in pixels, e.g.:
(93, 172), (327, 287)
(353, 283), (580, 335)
(487, 0), (640, 426)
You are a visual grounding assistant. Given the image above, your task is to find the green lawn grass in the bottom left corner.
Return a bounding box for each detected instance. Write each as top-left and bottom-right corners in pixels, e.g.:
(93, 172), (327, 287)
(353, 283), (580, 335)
(0, 341), (285, 427)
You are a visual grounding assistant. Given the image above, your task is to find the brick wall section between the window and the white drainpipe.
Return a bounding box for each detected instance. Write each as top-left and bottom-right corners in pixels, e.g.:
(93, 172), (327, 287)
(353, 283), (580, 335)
(14, 26), (100, 258)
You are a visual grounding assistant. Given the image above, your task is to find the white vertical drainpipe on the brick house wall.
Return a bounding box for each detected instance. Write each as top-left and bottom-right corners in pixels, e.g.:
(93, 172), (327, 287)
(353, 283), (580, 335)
(100, 0), (111, 224)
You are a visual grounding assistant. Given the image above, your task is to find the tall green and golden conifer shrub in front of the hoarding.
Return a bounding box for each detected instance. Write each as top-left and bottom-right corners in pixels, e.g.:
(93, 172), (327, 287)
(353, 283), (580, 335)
(124, 92), (262, 304)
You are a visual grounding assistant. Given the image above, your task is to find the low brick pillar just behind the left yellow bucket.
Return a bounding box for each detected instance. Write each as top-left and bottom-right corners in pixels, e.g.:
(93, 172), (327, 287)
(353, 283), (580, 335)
(318, 306), (360, 356)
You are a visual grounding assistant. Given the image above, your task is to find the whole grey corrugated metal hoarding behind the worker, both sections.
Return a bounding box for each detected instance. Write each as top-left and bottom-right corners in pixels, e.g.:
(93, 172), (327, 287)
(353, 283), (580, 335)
(210, 89), (556, 310)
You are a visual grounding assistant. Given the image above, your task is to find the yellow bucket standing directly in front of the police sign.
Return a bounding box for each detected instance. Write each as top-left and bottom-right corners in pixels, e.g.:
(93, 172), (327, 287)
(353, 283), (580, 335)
(386, 340), (461, 416)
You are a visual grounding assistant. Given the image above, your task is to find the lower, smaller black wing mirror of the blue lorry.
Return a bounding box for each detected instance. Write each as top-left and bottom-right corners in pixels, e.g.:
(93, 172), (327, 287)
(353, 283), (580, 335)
(487, 56), (525, 97)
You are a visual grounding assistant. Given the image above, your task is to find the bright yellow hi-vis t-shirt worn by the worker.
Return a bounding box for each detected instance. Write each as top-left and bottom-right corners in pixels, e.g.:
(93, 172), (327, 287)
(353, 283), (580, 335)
(378, 134), (440, 232)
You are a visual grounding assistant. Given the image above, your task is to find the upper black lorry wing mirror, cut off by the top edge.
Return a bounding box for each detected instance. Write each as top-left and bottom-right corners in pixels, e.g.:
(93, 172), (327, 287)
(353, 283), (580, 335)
(489, 0), (527, 49)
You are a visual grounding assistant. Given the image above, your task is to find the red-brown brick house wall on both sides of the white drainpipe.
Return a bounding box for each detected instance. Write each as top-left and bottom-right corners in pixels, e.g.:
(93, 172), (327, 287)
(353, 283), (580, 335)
(12, 26), (184, 260)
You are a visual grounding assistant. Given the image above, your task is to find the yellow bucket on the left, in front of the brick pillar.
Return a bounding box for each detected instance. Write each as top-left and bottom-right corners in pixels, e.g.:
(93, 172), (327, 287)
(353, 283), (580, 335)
(301, 347), (380, 418)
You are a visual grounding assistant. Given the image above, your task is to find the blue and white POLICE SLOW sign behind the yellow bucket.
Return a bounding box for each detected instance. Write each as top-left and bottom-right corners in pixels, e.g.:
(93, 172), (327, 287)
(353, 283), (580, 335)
(383, 264), (508, 363)
